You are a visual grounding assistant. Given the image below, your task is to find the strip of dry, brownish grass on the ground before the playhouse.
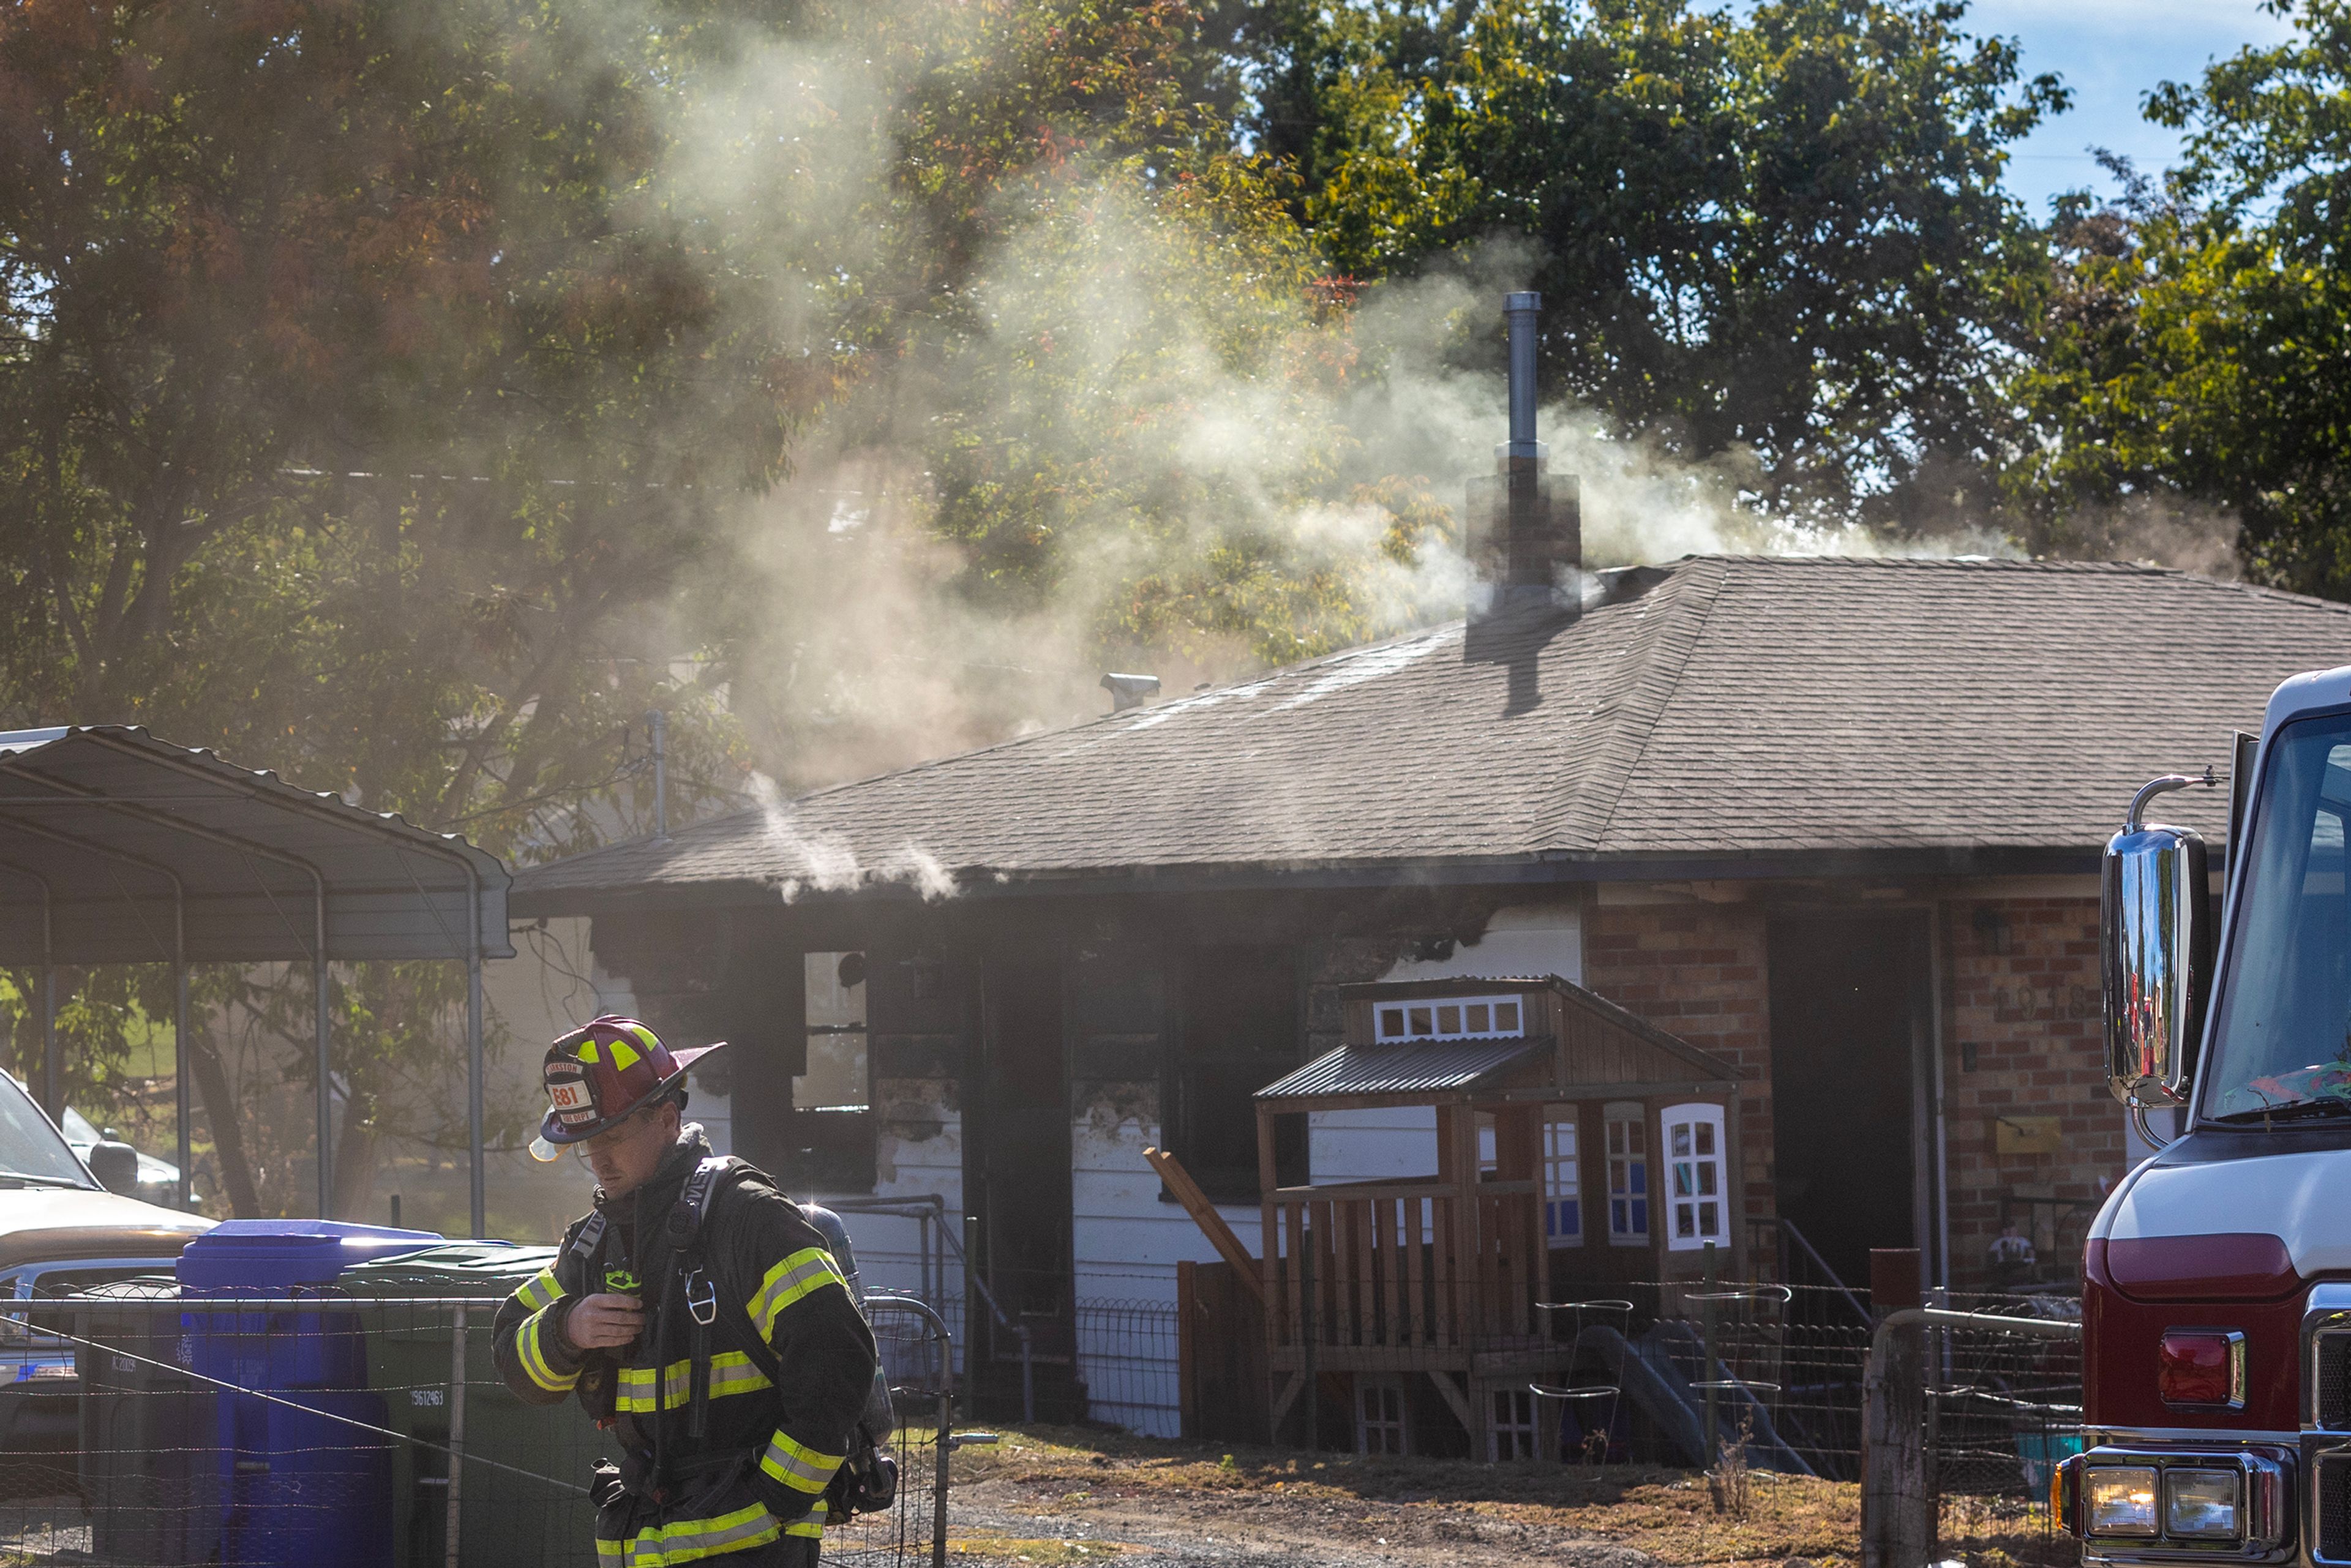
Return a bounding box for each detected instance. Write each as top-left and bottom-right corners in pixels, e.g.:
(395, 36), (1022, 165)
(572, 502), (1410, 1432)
(954, 1427), (2064, 1568)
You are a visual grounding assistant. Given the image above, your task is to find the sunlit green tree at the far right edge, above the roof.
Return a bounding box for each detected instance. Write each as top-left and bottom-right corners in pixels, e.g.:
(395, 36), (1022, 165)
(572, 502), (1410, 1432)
(2010, 0), (2351, 597)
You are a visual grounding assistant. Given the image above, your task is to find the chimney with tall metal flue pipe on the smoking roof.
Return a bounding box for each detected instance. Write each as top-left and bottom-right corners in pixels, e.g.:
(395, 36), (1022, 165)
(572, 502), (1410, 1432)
(1467, 294), (1584, 621)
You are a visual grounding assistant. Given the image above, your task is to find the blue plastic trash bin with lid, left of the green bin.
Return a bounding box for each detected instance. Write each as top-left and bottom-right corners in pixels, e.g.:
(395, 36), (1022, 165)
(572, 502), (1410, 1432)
(176, 1220), (442, 1568)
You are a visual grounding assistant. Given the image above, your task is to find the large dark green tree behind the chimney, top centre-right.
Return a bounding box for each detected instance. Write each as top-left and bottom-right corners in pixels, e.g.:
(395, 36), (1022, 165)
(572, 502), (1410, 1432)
(1262, 0), (2066, 529)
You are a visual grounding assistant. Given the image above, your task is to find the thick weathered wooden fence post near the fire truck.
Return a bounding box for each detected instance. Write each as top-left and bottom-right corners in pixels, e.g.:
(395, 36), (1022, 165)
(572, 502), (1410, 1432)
(1862, 1246), (1935, 1568)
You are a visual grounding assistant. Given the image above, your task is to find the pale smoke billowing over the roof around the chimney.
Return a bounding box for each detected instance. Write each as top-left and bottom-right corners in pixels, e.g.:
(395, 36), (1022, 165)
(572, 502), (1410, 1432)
(639, 7), (2226, 799)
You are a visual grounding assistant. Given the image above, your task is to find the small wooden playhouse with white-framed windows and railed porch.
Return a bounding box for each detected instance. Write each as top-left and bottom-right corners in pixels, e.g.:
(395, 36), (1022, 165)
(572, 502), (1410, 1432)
(1256, 975), (1747, 1460)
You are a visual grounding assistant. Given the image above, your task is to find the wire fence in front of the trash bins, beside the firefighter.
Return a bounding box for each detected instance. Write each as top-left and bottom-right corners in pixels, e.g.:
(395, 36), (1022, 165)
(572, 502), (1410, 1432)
(0, 1279), (952, 1568)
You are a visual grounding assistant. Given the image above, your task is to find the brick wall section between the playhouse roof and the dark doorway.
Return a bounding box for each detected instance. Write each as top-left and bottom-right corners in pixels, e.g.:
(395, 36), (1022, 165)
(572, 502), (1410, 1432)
(1584, 905), (1772, 1215)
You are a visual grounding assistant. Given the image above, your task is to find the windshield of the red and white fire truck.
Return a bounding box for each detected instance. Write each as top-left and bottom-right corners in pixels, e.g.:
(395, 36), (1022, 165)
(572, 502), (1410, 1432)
(2203, 715), (2351, 1121)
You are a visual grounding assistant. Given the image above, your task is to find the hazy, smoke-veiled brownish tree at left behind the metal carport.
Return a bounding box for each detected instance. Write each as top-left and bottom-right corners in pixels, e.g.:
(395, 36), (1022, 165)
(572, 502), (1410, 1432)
(0, 0), (792, 1206)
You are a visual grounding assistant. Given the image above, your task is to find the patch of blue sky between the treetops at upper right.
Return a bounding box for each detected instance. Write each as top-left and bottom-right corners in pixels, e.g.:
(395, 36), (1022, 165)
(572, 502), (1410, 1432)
(1968, 0), (2292, 216)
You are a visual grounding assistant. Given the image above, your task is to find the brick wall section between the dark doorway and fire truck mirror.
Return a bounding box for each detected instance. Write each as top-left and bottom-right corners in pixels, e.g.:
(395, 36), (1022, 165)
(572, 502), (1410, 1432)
(1942, 898), (2125, 1286)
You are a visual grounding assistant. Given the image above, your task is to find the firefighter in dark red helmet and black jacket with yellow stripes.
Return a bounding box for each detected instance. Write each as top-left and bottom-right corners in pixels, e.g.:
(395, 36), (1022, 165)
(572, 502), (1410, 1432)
(496, 1016), (874, 1568)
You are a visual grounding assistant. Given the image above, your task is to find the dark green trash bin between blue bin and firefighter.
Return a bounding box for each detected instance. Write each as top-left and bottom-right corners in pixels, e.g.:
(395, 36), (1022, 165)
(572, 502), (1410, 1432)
(341, 1241), (611, 1568)
